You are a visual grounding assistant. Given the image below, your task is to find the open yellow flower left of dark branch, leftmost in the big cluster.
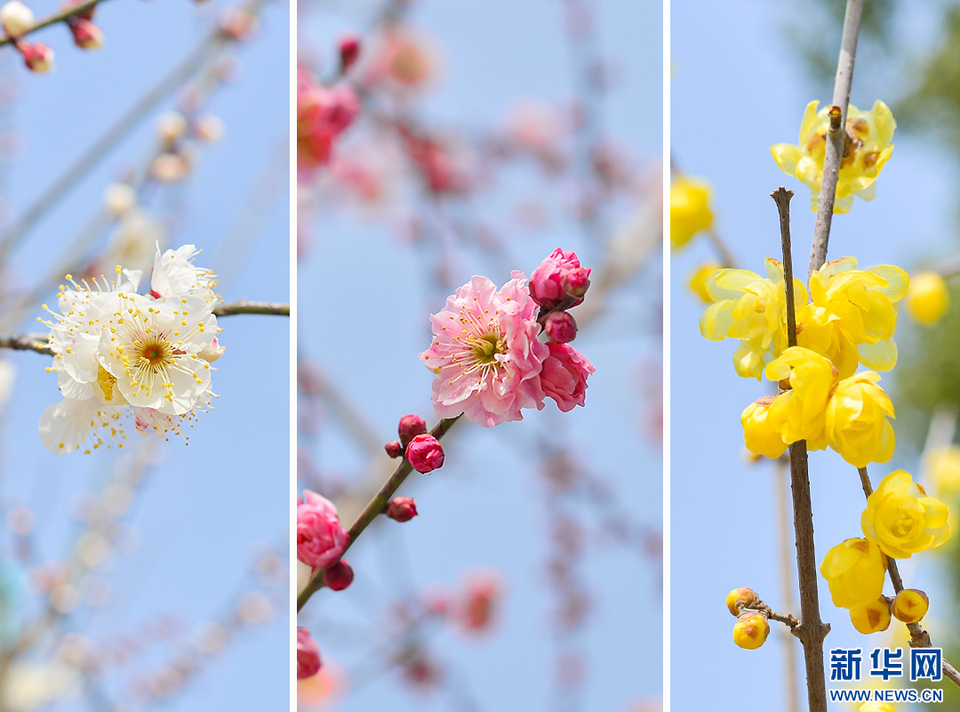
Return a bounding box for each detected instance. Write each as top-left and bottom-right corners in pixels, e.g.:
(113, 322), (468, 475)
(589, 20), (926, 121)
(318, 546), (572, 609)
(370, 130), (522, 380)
(700, 258), (807, 381)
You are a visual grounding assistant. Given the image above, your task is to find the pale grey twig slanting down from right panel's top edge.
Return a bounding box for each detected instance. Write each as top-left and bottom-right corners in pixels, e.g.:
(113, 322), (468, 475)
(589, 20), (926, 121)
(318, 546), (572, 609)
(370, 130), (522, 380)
(807, 0), (863, 281)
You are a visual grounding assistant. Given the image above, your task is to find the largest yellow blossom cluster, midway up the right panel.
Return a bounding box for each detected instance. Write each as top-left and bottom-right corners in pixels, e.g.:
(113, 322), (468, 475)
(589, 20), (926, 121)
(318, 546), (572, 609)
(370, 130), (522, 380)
(700, 257), (910, 467)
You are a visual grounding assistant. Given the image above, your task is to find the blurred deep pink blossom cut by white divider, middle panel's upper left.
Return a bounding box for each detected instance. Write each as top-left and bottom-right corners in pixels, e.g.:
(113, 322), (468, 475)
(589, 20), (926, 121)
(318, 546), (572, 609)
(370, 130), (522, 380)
(297, 67), (360, 171)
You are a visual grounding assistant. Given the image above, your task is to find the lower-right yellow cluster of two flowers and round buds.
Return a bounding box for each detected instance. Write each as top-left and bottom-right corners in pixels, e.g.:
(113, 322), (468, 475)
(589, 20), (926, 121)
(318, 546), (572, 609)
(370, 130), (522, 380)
(820, 470), (950, 634)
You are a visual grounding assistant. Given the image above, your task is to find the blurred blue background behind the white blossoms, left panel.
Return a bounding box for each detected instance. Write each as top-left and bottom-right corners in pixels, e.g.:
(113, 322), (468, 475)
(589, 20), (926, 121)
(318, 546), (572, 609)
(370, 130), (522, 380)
(0, 0), (290, 712)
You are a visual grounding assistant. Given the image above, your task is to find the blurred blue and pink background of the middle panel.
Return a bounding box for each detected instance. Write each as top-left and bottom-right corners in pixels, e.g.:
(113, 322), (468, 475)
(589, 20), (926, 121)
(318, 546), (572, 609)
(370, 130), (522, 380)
(297, 0), (663, 712)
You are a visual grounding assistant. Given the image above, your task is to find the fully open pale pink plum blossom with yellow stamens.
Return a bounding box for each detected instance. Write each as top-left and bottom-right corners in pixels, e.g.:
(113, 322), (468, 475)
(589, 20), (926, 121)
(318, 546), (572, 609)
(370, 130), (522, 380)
(420, 271), (549, 428)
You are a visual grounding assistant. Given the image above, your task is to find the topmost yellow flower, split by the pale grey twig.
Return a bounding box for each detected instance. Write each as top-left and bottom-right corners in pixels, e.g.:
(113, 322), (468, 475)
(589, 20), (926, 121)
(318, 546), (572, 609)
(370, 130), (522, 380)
(770, 100), (897, 213)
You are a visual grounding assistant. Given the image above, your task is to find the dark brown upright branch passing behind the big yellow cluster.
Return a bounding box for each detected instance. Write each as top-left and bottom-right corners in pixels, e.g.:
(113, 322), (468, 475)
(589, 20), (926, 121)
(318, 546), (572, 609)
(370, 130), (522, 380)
(770, 187), (830, 712)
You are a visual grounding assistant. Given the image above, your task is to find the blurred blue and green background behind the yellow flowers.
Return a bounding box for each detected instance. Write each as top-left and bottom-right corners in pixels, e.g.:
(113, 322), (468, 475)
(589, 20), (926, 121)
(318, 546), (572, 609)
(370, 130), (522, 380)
(670, 0), (960, 711)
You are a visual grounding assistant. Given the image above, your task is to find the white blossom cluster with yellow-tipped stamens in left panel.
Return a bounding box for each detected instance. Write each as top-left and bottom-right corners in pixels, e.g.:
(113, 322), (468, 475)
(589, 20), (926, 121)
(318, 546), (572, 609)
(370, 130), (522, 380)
(39, 245), (224, 455)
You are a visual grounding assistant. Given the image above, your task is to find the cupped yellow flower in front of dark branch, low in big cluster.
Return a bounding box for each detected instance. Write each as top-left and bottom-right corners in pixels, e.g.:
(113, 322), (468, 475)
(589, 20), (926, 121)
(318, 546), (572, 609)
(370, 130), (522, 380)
(766, 346), (837, 450)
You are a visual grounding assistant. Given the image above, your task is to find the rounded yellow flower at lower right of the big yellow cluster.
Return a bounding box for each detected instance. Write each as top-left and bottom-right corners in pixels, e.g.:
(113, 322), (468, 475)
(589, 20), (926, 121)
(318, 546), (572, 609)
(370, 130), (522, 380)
(823, 371), (896, 467)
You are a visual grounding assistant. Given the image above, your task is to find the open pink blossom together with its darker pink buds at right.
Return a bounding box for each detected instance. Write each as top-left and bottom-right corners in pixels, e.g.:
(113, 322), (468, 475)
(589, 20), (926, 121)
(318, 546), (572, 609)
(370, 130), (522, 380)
(420, 248), (596, 427)
